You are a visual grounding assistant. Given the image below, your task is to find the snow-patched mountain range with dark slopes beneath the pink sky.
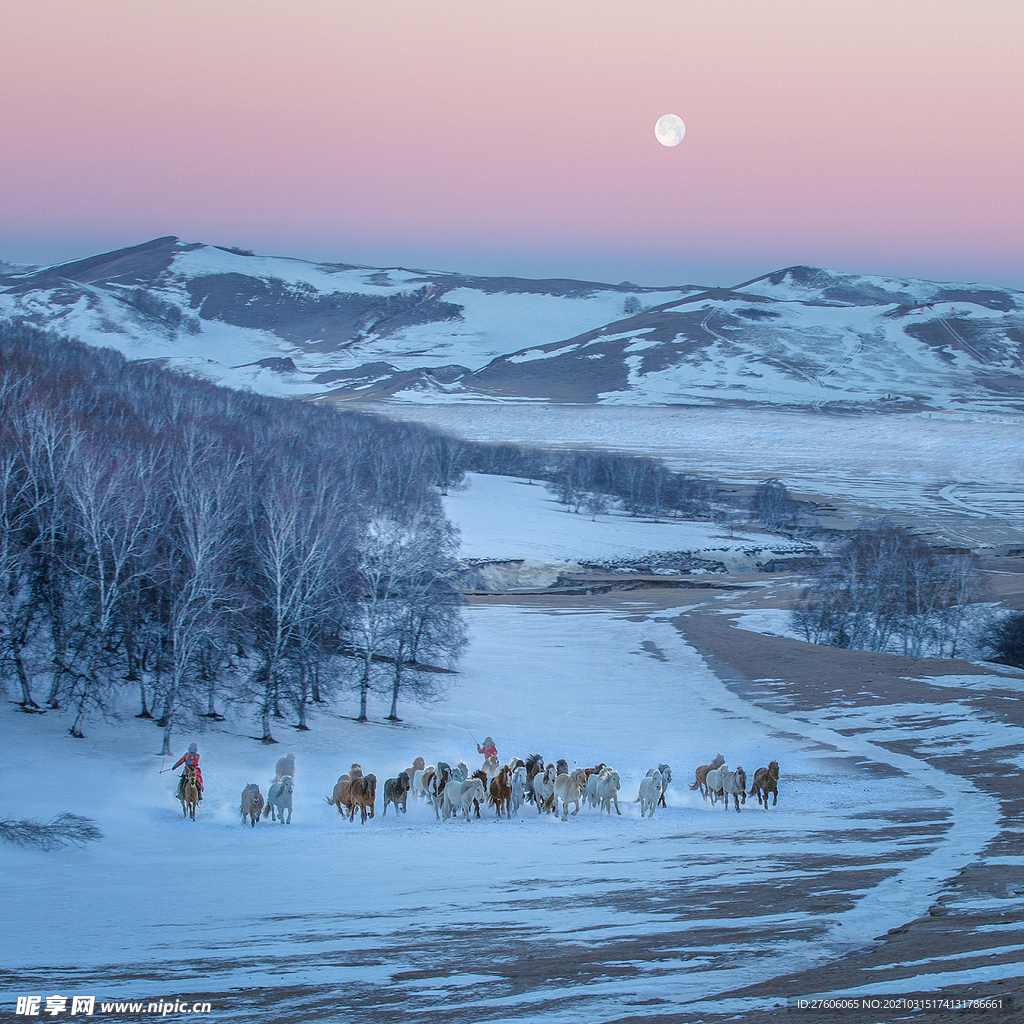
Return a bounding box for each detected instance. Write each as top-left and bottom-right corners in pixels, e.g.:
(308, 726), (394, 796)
(0, 238), (1024, 412)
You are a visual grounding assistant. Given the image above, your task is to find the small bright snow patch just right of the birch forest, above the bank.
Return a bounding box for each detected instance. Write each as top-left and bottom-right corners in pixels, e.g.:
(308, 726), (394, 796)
(444, 473), (813, 565)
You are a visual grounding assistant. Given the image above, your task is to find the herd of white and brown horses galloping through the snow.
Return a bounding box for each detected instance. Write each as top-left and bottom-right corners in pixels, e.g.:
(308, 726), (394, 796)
(181, 754), (779, 827)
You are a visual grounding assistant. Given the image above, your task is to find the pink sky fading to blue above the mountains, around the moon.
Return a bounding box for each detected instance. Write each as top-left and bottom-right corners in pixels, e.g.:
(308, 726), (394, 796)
(0, 0), (1024, 289)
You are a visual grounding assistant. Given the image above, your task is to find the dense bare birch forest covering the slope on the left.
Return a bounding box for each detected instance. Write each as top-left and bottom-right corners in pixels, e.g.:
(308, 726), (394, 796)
(0, 326), (465, 752)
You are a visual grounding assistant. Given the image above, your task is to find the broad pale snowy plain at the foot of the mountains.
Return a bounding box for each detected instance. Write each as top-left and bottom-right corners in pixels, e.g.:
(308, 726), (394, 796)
(373, 404), (1024, 546)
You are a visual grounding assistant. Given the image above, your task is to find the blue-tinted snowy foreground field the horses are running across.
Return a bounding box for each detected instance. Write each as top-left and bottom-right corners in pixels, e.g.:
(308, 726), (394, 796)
(0, 601), (1024, 1024)
